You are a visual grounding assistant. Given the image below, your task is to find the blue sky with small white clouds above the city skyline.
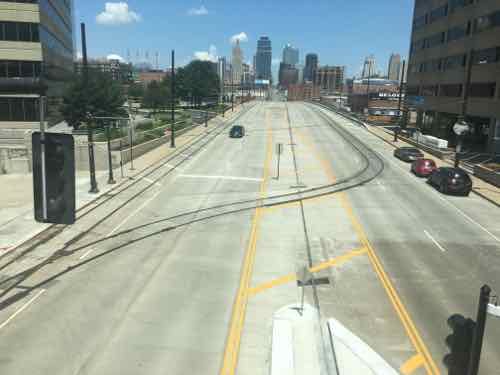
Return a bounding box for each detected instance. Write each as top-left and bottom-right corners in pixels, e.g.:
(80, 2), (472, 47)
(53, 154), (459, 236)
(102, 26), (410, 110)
(74, 0), (413, 76)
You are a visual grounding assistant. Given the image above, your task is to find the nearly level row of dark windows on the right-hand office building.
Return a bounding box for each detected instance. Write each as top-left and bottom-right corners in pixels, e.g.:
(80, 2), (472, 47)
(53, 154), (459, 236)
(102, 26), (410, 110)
(406, 82), (497, 98)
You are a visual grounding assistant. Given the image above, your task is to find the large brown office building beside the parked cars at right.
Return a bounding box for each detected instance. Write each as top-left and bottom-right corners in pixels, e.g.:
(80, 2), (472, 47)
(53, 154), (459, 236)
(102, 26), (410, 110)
(406, 0), (500, 153)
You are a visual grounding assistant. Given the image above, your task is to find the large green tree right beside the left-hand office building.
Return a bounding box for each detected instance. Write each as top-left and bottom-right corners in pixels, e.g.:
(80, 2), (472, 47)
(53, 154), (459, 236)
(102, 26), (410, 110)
(61, 70), (125, 129)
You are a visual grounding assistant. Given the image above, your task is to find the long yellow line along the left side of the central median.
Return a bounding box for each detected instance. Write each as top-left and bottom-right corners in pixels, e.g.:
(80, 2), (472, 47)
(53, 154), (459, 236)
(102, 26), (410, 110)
(219, 111), (273, 375)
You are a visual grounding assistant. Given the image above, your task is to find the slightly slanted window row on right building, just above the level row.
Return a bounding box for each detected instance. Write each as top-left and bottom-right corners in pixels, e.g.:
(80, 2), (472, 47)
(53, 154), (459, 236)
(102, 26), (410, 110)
(409, 46), (500, 73)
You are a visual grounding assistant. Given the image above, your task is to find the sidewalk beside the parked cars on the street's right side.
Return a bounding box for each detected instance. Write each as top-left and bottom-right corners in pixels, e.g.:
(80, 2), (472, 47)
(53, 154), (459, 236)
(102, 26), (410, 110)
(366, 124), (500, 207)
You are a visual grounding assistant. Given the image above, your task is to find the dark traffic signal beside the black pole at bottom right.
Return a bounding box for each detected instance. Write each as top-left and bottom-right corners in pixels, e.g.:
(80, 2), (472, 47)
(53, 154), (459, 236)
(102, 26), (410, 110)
(443, 314), (476, 375)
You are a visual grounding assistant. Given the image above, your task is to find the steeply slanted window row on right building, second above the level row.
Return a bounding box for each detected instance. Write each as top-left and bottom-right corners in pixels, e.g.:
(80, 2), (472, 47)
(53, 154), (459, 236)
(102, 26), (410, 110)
(410, 11), (500, 54)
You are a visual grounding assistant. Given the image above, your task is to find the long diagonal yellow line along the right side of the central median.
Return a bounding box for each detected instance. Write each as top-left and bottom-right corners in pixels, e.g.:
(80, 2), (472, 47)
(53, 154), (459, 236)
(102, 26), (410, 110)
(294, 125), (440, 375)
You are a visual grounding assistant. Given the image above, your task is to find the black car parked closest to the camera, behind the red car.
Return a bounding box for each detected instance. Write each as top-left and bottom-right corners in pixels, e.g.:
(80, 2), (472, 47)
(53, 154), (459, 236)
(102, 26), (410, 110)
(427, 167), (472, 196)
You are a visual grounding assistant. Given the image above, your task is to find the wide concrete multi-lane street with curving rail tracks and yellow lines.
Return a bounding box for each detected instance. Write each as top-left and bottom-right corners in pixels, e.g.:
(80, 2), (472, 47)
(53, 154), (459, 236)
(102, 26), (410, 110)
(0, 102), (500, 375)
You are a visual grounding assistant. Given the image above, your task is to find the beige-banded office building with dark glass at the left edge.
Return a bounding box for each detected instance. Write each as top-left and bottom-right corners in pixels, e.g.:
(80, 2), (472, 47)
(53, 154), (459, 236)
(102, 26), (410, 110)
(0, 0), (74, 130)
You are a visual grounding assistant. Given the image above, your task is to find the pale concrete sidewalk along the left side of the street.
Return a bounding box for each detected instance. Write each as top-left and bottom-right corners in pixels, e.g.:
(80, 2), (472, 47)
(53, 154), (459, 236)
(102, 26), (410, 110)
(0, 106), (246, 257)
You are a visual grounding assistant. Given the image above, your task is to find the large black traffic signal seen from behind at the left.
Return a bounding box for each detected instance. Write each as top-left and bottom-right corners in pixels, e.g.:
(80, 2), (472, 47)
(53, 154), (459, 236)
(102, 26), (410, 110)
(32, 132), (75, 224)
